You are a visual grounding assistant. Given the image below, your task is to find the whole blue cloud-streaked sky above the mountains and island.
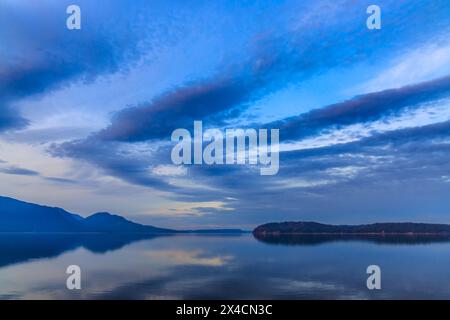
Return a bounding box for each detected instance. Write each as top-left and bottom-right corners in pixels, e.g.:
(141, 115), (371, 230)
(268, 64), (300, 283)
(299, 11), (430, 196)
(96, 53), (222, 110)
(0, 0), (450, 229)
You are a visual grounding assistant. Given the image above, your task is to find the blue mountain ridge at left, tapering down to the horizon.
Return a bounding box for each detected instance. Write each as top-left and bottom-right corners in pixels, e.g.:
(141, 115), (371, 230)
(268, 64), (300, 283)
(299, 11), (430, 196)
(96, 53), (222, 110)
(0, 196), (243, 234)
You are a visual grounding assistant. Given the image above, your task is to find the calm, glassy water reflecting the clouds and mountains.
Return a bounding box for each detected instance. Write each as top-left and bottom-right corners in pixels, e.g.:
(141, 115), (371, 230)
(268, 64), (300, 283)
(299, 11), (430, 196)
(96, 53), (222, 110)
(0, 234), (450, 299)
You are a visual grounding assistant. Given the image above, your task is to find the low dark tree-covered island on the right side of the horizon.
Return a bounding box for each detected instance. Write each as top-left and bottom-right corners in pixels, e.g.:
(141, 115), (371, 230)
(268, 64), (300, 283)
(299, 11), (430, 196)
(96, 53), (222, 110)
(253, 222), (450, 235)
